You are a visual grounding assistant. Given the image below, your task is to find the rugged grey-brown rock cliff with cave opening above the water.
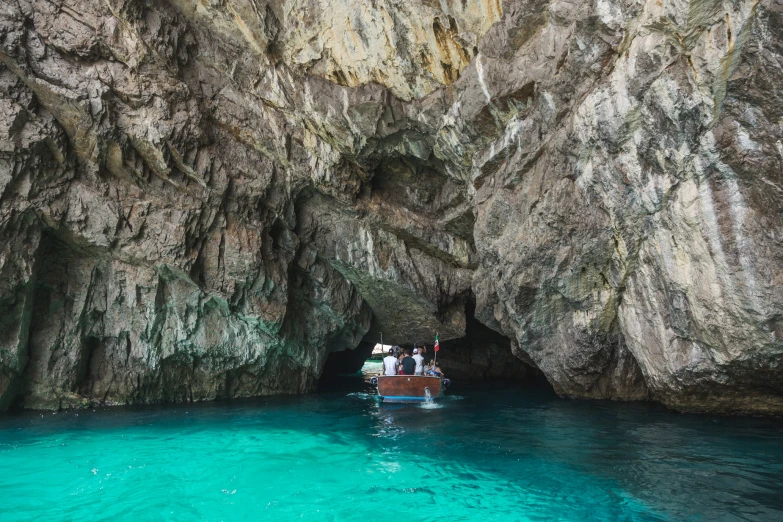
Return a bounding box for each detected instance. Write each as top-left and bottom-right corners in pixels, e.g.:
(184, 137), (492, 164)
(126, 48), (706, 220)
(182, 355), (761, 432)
(0, 0), (783, 412)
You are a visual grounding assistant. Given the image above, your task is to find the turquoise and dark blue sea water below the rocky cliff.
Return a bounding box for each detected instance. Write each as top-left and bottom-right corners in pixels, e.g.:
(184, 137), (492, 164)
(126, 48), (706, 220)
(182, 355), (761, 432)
(0, 360), (783, 521)
